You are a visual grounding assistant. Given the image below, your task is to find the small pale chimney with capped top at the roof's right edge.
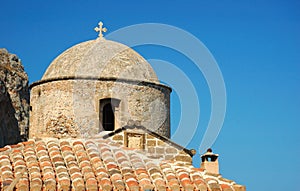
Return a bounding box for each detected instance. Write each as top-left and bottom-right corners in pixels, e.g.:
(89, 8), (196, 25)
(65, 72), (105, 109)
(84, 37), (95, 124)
(201, 148), (219, 174)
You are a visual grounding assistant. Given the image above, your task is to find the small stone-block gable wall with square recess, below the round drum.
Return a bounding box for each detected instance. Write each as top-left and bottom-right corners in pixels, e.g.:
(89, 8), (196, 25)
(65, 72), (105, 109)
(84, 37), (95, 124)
(109, 128), (195, 165)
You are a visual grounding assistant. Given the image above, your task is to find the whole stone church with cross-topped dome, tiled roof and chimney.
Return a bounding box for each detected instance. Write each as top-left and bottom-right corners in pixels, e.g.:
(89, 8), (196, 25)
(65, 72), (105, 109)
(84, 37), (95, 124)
(0, 22), (246, 191)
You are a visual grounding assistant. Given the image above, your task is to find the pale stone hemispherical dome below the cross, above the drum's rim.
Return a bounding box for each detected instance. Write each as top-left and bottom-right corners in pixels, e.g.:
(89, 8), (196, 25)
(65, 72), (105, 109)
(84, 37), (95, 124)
(42, 38), (158, 82)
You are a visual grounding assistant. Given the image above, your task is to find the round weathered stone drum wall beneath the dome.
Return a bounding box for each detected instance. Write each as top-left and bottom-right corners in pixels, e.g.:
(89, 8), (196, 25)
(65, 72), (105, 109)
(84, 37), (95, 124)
(30, 79), (171, 138)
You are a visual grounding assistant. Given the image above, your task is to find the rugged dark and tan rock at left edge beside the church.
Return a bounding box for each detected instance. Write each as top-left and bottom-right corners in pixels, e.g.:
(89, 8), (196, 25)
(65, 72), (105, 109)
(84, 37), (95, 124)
(0, 49), (29, 147)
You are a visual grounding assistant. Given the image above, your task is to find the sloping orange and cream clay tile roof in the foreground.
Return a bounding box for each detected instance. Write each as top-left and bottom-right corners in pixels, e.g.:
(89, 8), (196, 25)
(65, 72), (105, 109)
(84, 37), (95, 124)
(0, 139), (245, 191)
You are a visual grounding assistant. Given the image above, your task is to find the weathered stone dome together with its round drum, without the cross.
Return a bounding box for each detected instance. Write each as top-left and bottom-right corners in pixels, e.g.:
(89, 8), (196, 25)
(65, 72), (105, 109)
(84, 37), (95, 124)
(30, 40), (171, 138)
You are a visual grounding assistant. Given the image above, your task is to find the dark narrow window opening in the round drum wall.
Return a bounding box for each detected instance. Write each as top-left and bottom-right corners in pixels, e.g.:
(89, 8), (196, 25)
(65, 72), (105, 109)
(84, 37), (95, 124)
(102, 103), (115, 131)
